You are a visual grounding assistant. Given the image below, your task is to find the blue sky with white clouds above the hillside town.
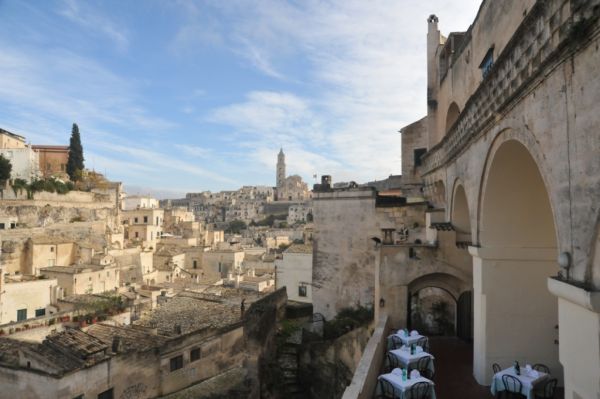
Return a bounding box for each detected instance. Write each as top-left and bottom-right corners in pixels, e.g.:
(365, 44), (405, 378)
(0, 0), (480, 198)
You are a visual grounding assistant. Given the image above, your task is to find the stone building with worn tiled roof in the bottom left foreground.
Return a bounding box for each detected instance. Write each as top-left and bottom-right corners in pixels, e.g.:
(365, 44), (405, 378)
(0, 291), (286, 399)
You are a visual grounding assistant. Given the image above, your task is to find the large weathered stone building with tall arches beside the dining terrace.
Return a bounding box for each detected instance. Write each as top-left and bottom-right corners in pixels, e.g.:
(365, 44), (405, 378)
(340, 0), (600, 399)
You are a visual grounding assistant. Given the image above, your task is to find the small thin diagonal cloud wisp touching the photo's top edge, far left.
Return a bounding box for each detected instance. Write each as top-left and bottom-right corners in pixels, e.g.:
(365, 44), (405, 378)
(59, 0), (129, 51)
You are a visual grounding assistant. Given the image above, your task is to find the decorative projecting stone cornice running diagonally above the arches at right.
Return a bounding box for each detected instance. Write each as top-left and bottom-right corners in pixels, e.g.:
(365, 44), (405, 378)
(421, 0), (600, 174)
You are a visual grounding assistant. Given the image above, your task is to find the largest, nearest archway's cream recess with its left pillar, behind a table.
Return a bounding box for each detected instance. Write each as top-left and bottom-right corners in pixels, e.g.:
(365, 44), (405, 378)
(470, 139), (562, 385)
